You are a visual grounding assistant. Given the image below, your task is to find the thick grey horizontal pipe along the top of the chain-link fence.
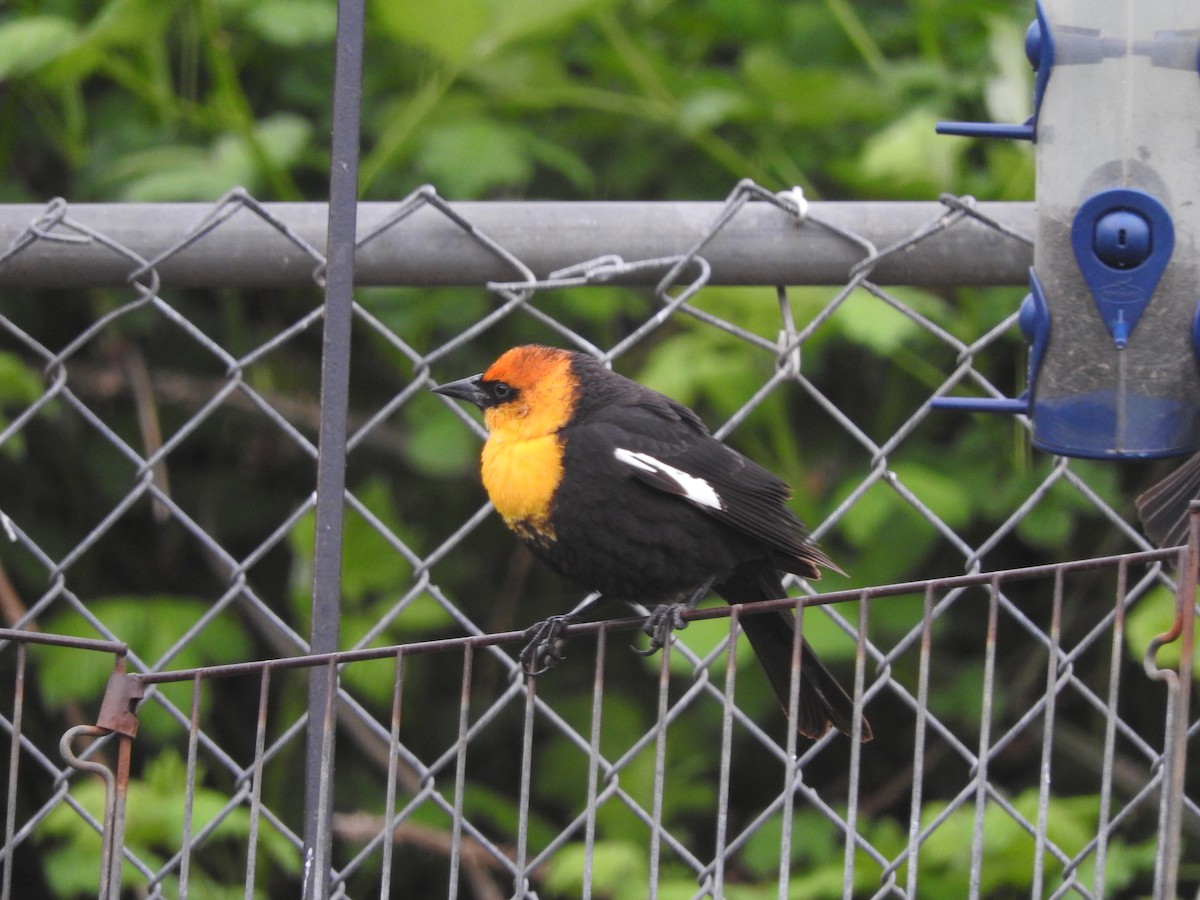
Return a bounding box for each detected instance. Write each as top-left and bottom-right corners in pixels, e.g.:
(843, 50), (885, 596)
(0, 198), (1034, 288)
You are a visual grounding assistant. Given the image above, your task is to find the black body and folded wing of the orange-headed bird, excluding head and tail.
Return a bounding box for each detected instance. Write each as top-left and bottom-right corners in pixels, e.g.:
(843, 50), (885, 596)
(542, 355), (828, 605)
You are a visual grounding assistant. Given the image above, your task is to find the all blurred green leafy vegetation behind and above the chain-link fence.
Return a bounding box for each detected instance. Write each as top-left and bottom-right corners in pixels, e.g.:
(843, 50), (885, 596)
(0, 0), (1200, 898)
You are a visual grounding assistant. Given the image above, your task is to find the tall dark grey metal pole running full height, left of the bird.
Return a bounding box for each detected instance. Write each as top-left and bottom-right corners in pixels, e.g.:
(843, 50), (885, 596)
(304, 0), (365, 899)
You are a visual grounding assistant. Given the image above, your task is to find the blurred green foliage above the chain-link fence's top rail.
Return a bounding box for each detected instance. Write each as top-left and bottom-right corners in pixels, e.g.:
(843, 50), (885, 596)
(0, 0), (1032, 200)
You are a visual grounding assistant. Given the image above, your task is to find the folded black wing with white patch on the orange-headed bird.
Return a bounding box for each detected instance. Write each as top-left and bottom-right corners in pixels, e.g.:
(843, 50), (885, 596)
(576, 398), (836, 574)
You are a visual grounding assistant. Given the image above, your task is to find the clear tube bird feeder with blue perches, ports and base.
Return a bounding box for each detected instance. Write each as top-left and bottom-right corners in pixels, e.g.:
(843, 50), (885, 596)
(935, 0), (1200, 458)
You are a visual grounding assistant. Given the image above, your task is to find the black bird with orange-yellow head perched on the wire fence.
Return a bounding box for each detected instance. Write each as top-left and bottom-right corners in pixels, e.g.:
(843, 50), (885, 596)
(434, 346), (871, 740)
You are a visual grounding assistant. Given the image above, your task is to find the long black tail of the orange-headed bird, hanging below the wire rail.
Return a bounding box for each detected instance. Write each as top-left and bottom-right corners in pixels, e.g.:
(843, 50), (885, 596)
(718, 569), (874, 743)
